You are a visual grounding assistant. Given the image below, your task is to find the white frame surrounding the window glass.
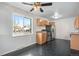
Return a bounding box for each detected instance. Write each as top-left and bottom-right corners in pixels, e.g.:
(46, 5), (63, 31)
(12, 13), (33, 37)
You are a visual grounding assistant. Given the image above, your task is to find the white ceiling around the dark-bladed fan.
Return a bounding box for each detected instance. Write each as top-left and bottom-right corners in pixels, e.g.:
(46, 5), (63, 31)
(8, 2), (79, 18)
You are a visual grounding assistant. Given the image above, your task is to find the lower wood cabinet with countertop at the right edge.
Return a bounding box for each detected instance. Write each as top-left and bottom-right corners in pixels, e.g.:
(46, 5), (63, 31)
(70, 33), (79, 50)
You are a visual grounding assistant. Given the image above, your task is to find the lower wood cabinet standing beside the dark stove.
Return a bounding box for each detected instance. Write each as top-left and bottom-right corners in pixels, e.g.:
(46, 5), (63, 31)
(36, 31), (47, 45)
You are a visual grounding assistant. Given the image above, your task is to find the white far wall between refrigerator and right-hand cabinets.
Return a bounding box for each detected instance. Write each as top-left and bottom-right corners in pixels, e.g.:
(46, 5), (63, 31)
(55, 17), (75, 40)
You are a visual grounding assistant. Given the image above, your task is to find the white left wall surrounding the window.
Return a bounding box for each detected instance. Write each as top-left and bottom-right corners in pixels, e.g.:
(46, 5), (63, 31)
(0, 3), (36, 55)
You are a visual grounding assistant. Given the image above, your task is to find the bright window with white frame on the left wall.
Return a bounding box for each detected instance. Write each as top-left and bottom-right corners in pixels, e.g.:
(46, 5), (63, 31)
(13, 15), (32, 36)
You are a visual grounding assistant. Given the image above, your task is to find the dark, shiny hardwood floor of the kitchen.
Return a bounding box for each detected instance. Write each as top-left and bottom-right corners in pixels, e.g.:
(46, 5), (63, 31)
(3, 39), (79, 56)
